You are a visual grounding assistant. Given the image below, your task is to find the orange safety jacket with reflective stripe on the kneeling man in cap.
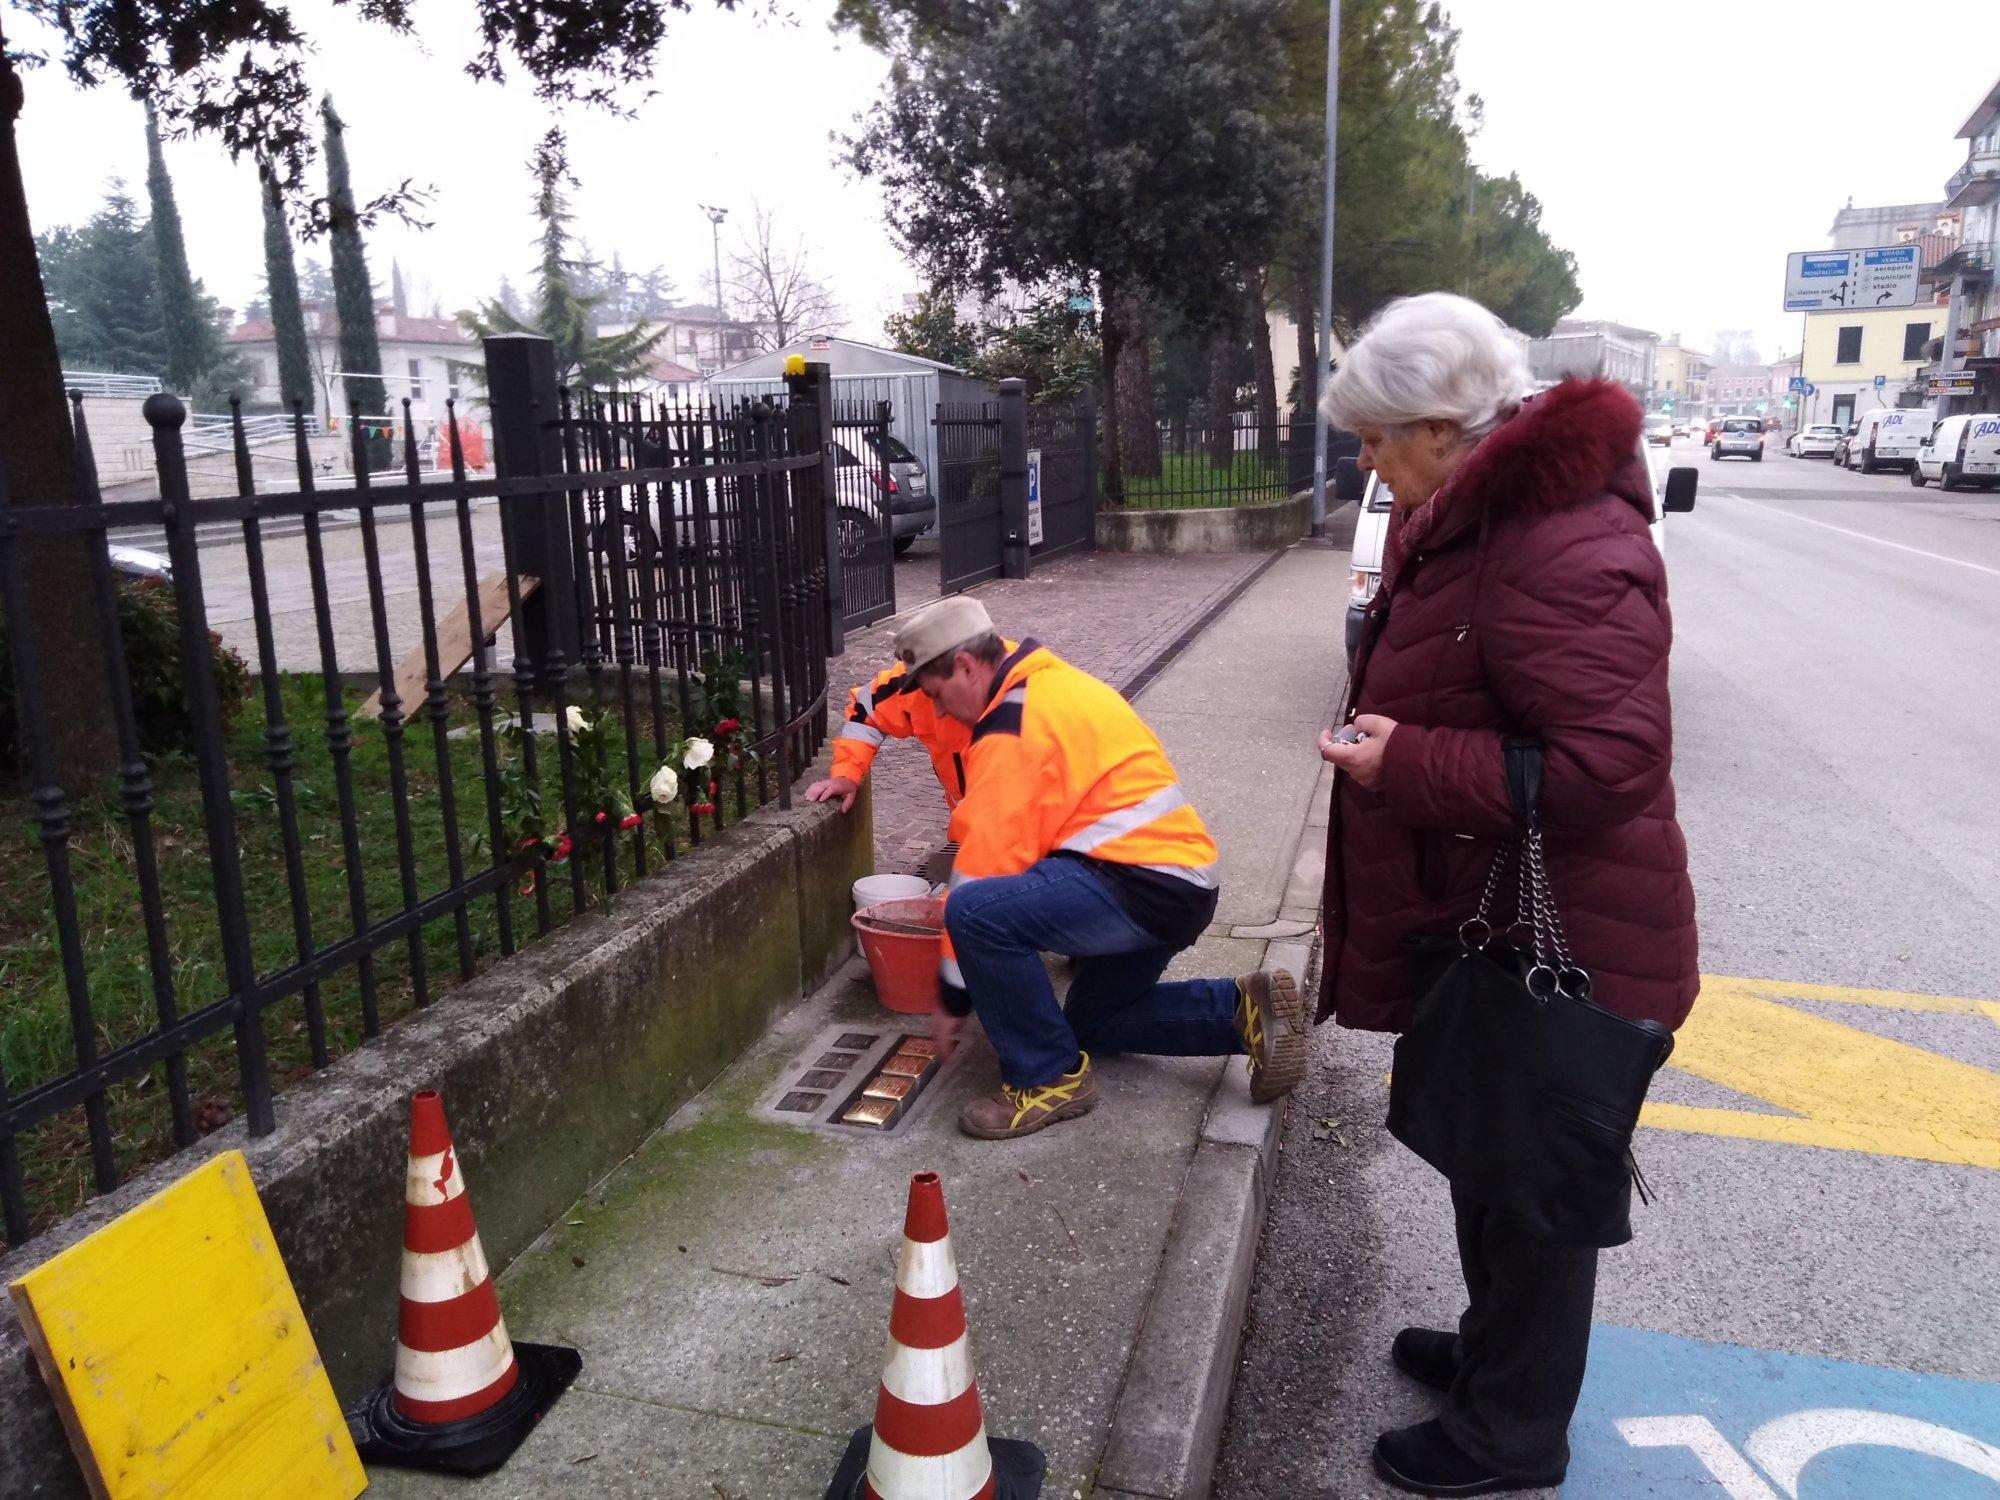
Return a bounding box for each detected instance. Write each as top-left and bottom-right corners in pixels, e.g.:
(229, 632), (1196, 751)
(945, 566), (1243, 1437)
(940, 640), (1216, 1014)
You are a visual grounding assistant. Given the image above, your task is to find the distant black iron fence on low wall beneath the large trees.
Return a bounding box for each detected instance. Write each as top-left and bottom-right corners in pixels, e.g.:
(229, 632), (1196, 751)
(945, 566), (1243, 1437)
(1106, 412), (1312, 510)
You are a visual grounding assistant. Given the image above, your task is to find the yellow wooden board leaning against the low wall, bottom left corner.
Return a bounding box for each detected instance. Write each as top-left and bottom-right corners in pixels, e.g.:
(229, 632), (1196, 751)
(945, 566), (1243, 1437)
(8, 1152), (368, 1500)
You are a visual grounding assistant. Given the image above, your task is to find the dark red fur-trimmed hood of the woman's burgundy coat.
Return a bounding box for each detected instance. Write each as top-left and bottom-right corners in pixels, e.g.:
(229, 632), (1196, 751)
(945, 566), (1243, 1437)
(1432, 380), (1652, 544)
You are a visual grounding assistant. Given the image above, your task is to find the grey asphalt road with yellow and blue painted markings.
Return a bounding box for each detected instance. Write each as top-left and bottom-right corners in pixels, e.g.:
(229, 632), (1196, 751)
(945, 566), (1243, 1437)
(1214, 442), (2000, 1500)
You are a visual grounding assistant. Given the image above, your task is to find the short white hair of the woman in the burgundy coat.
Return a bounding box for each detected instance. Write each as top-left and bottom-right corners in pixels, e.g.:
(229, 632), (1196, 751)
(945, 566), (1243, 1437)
(1320, 292), (1528, 440)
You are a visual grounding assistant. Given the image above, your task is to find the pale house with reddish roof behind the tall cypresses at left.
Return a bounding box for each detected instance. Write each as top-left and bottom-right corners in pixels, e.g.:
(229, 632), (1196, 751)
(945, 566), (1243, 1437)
(228, 306), (486, 422)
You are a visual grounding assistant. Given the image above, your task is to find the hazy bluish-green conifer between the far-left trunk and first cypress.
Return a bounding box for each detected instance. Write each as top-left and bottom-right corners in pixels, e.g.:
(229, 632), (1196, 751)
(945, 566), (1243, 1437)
(36, 178), (166, 378)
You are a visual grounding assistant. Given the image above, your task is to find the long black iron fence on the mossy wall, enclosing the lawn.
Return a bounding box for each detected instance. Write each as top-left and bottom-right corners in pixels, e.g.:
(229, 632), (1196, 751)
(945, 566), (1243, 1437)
(0, 340), (838, 1244)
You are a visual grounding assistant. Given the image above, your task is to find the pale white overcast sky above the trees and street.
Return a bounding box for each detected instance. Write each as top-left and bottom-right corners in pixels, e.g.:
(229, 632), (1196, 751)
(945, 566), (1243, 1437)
(10, 0), (2000, 358)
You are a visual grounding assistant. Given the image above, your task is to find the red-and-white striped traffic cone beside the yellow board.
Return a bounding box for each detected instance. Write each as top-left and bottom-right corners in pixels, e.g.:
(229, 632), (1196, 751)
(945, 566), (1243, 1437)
(348, 1088), (584, 1474)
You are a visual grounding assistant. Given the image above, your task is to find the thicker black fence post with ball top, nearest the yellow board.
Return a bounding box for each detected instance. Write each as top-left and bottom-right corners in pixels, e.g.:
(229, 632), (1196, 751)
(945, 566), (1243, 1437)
(142, 392), (278, 1136)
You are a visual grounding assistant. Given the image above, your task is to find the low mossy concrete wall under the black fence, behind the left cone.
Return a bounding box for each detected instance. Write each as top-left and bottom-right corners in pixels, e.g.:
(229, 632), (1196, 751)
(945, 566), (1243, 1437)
(0, 764), (874, 1500)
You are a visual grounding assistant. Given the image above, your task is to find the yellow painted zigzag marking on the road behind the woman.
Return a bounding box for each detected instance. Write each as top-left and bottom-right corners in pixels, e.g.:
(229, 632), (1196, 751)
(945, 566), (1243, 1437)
(1640, 976), (2000, 1168)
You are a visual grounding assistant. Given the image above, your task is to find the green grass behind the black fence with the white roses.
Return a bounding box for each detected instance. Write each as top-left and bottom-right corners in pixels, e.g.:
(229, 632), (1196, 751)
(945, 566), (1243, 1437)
(0, 674), (776, 1226)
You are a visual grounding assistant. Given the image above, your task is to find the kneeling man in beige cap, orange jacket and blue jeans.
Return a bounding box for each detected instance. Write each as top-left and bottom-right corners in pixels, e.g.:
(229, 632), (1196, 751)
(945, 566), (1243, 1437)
(896, 596), (1306, 1140)
